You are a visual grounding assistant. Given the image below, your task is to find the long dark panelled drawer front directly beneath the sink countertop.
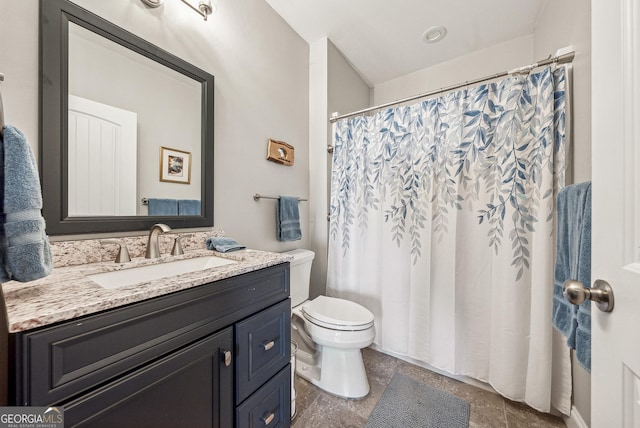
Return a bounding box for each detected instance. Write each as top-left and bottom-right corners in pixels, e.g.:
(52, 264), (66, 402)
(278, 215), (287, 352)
(10, 263), (289, 406)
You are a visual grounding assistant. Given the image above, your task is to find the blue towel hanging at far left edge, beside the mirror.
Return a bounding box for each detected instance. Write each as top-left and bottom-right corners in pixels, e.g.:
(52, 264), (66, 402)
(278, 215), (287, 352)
(0, 125), (53, 282)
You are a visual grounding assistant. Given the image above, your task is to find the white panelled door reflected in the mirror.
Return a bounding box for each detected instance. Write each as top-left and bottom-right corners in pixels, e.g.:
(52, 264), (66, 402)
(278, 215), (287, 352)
(67, 95), (138, 217)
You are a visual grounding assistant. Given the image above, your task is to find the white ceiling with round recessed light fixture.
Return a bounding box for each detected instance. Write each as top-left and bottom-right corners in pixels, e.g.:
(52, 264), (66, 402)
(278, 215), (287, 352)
(266, 0), (548, 86)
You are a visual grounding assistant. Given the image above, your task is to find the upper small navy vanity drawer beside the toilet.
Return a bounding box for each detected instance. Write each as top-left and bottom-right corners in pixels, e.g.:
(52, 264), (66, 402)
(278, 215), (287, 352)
(235, 299), (291, 404)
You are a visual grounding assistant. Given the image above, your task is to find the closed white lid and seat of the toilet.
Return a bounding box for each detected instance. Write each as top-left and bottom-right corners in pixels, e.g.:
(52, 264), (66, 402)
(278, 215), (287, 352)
(302, 296), (373, 331)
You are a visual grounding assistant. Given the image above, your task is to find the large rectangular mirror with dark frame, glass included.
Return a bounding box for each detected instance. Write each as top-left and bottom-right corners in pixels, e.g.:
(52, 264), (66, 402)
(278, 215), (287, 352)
(40, 0), (214, 235)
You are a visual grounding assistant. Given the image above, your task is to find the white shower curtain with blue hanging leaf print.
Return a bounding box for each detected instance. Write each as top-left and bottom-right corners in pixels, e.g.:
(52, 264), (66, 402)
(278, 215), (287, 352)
(327, 67), (571, 411)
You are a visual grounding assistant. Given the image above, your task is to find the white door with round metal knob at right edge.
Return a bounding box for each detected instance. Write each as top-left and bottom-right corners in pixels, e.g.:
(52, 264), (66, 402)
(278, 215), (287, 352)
(591, 0), (640, 428)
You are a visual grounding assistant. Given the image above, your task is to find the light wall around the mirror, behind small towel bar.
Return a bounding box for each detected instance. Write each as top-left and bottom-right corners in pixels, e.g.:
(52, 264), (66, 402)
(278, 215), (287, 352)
(0, 0), (309, 251)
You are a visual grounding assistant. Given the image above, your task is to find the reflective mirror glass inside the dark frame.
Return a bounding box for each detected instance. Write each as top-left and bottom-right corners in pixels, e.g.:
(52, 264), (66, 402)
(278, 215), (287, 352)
(67, 22), (202, 217)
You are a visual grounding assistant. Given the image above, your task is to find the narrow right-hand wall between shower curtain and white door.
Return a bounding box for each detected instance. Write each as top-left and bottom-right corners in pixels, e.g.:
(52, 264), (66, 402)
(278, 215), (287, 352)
(534, 0), (591, 425)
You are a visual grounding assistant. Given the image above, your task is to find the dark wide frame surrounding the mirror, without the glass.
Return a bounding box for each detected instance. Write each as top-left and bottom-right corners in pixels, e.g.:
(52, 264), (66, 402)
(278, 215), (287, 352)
(39, 0), (214, 235)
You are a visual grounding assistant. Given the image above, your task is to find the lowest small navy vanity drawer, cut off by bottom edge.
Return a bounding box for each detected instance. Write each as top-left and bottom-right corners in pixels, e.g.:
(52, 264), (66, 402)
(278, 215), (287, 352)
(236, 364), (291, 428)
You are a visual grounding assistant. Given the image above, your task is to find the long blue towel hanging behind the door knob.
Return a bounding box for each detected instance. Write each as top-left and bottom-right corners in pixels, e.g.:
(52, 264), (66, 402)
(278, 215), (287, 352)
(552, 182), (591, 371)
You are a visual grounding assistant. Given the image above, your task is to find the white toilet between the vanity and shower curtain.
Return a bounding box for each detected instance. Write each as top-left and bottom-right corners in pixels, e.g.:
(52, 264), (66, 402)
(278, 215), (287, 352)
(285, 250), (375, 398)
